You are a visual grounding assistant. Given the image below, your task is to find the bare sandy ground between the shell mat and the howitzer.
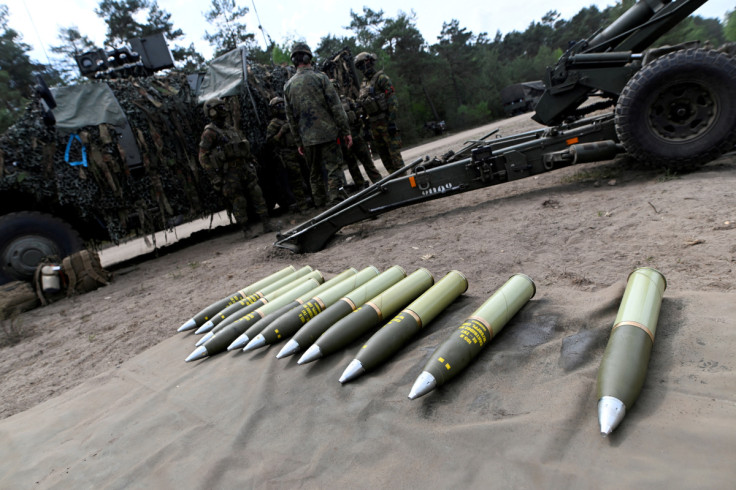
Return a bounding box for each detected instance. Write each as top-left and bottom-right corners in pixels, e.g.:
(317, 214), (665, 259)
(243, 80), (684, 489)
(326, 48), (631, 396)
(0, 110), (736, 418)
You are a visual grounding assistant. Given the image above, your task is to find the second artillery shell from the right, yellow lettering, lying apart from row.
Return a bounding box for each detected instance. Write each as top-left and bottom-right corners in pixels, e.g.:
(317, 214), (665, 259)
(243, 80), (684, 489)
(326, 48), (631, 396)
(409, 274), (536, 400)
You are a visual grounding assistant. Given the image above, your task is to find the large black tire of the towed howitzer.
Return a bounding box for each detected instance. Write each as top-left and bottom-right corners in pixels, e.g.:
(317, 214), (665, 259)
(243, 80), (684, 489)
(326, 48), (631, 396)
(615, 49), (736, 170)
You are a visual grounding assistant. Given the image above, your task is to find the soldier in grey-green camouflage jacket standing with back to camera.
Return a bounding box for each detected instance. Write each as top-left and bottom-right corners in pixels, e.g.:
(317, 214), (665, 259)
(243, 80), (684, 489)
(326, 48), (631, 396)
(284, 43), (353, 207)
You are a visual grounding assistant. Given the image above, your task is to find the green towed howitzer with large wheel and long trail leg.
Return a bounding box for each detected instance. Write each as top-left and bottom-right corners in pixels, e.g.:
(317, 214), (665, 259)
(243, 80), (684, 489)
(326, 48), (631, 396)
(275, 0), (736, 252)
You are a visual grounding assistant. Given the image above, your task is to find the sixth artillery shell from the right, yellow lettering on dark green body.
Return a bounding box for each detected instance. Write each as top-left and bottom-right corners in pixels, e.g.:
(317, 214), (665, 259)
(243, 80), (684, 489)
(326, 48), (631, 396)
(246, 266), (378, 350)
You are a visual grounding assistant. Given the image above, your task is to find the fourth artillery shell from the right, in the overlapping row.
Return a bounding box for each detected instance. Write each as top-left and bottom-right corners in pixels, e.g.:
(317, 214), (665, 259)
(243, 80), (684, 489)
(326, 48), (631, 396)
(298, 268), (434, 364)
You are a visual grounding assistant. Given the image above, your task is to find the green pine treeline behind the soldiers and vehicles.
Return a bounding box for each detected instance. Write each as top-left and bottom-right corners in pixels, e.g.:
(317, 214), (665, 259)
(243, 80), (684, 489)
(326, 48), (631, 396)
(0, 0), (736, 143)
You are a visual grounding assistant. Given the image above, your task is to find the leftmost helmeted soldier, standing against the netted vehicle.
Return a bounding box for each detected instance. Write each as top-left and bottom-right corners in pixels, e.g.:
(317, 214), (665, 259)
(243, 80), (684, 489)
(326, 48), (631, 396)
(199, 98), (275, 238)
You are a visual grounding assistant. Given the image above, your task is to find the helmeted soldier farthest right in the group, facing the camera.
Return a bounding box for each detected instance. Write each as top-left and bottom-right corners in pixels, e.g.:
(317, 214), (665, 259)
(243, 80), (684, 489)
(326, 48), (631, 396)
(355, 52), (404, 173)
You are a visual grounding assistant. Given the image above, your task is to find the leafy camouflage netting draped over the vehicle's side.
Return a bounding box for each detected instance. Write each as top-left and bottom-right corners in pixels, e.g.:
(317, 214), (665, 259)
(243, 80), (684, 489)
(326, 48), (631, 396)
(0, 57), (296, 247)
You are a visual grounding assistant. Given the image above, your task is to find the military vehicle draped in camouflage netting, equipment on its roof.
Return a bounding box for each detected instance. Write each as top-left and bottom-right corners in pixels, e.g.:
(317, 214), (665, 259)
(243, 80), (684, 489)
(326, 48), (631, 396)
(0, 35), (289, 284)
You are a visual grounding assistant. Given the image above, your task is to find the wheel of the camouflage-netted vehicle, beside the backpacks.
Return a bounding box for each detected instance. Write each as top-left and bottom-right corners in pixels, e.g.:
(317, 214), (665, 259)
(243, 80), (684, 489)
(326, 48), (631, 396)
(0, 211), (84, 284)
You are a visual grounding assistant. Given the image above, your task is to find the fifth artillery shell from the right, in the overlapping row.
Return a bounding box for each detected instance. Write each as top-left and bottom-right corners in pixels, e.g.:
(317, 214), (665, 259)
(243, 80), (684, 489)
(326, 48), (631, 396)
(276, 265), (406, 359)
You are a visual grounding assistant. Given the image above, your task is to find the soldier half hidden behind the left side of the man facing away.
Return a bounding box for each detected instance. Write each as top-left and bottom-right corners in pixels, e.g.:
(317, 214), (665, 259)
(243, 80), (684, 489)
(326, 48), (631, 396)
(266, 97), (309, 214)
